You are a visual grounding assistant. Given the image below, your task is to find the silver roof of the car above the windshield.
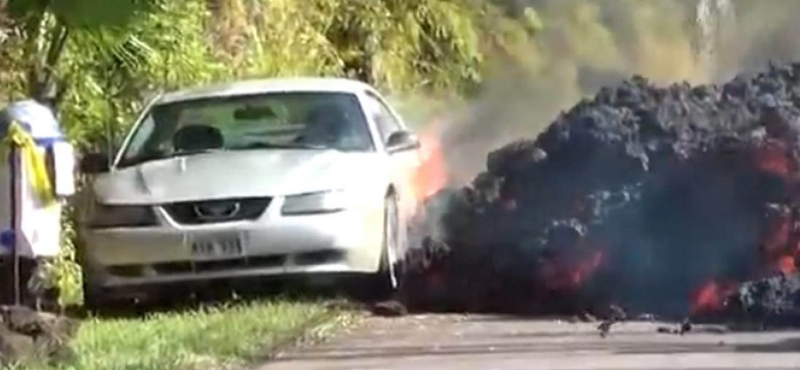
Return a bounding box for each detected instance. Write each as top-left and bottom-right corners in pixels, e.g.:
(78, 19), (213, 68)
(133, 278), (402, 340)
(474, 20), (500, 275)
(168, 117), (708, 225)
(155, 77), (375, 104)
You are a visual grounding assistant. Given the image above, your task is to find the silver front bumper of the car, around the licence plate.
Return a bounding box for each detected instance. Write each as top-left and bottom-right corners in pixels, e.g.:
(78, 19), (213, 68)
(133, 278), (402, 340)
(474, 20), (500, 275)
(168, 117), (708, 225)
(83, 198), (383, 288)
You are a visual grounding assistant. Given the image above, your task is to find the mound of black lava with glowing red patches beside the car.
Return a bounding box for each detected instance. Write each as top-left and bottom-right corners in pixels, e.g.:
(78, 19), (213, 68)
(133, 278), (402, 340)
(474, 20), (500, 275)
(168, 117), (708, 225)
(403, 64), (800, 316)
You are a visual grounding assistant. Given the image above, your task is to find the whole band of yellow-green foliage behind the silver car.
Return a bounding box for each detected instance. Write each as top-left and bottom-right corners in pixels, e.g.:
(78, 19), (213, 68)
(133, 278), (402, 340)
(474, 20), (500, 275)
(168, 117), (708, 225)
(6, 0), (535, 147)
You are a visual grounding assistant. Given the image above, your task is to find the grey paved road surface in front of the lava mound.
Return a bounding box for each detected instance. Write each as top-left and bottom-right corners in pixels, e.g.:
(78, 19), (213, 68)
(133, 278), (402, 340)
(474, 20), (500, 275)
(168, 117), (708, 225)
(259, 315), (800, 370)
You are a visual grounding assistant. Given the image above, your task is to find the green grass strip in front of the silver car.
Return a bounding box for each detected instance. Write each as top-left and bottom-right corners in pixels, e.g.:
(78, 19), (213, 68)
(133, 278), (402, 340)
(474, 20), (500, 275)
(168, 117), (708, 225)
(26, 300), (350, 370)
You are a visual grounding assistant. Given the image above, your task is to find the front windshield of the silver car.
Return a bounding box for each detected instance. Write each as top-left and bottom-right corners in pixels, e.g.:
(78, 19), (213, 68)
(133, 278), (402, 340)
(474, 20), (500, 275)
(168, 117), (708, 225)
(120, 92), (373, 166)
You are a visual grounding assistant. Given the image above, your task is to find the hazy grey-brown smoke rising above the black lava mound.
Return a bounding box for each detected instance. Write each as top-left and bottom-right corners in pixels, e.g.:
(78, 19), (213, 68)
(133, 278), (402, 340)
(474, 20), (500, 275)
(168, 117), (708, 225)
(442, 0), (800, 184)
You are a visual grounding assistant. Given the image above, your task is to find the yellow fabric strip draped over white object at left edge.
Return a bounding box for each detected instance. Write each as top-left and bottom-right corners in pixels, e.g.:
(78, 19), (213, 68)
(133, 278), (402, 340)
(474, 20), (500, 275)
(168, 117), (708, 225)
(3, 122), (56, 207)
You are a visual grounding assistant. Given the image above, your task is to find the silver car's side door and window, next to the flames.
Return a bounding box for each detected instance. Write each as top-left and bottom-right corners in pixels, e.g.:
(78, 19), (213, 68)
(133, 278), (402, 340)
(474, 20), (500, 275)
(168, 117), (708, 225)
(366, 91), (420, 228)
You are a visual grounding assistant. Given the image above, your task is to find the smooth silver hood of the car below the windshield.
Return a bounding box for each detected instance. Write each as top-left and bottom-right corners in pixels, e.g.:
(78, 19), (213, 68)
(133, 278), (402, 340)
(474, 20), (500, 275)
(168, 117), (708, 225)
(94, 150), (388, 204)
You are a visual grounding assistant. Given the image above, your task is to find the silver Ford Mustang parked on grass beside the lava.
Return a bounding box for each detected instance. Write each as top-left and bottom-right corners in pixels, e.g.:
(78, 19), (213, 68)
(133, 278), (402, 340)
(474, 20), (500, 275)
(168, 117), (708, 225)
(79, 78), (420, 305)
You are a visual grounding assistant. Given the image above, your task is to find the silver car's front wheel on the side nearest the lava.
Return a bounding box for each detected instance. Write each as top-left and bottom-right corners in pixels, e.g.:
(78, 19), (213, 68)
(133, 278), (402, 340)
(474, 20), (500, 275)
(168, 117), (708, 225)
(374, 195), (400, 297)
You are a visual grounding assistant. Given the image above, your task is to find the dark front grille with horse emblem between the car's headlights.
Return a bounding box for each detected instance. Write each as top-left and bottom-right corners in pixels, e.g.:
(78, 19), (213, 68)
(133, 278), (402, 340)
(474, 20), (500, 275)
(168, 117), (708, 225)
(164, 198), (272, 225)
